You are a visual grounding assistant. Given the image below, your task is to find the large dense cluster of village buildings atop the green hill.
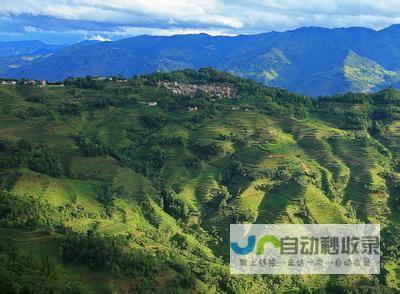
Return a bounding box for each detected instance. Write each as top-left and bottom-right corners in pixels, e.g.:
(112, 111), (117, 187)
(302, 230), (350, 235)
(158, 82), (238, 99)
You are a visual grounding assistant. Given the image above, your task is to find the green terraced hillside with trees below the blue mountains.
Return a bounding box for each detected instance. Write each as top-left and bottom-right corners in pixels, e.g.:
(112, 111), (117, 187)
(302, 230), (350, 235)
(0, 69), (400, 293)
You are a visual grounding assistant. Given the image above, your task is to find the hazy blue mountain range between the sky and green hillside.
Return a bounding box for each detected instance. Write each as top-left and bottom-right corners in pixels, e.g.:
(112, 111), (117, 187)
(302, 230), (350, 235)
(0, 25), (400, 96)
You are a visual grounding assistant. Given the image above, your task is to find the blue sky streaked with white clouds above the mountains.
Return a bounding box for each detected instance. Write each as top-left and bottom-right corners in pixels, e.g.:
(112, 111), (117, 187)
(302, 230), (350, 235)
(0, 0), (400, 44)
